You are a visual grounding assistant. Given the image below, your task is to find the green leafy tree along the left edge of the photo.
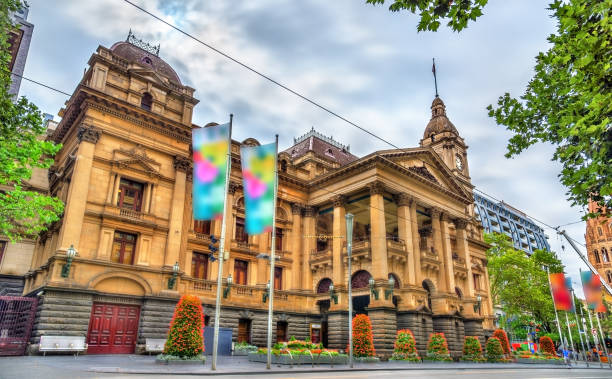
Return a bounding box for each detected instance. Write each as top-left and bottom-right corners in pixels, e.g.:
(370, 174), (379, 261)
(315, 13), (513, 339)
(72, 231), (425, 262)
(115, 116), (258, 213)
(0, 0), (64, 241)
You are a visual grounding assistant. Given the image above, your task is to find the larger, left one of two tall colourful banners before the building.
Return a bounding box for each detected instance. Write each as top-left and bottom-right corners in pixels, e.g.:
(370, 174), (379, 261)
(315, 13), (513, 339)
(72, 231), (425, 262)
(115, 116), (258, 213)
(192, 124), (230, 220)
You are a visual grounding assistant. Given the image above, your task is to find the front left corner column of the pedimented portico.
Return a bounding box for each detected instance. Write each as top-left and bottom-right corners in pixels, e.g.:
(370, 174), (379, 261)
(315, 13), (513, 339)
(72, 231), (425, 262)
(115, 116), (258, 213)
(370, 182), (389, 283)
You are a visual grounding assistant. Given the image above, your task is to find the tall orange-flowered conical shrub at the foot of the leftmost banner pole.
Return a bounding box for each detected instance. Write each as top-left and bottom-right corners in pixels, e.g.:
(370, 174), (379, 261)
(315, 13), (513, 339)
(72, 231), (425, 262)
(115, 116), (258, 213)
(164, 295), (204, 358)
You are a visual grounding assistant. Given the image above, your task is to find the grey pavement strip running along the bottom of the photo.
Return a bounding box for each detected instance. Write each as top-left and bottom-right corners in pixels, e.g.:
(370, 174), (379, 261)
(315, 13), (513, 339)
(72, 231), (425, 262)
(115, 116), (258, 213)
(0, 355), (609, 375)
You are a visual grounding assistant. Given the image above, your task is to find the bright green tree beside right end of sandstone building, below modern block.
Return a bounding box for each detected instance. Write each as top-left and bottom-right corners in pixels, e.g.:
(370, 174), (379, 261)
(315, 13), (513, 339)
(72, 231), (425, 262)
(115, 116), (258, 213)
(485, 233), (563, 332)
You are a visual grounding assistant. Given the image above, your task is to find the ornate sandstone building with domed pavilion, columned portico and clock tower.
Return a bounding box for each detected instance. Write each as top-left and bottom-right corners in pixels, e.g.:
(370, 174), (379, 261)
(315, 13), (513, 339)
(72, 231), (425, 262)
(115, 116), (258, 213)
(24, 36), (493, 354)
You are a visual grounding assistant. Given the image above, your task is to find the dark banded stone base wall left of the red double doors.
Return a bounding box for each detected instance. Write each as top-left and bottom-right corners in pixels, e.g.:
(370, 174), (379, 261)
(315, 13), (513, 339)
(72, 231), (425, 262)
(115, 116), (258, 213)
(29, 289), (93, 354)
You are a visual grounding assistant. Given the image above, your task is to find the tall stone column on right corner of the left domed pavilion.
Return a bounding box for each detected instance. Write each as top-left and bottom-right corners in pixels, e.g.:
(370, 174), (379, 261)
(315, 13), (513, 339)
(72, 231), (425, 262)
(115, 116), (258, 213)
(164, 156), (190, 267)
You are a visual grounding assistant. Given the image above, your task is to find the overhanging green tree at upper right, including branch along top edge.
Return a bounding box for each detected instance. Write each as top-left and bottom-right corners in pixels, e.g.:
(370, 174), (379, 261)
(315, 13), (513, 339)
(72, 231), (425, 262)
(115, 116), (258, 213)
(367, 0), (612, 217)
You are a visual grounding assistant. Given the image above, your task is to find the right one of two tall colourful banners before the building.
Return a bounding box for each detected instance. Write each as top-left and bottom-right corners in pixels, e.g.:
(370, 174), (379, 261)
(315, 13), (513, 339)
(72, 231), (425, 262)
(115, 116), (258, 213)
(240, 143), (277, 234)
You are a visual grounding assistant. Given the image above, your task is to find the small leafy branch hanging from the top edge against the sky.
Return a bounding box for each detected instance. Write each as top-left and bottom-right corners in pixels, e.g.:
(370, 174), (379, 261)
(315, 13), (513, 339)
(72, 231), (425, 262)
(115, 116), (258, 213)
(366, 0), (488, 32)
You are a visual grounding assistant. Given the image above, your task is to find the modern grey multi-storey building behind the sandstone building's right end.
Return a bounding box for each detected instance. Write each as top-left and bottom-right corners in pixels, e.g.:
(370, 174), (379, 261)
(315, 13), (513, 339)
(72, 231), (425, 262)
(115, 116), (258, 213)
(474, 193), (550, 254)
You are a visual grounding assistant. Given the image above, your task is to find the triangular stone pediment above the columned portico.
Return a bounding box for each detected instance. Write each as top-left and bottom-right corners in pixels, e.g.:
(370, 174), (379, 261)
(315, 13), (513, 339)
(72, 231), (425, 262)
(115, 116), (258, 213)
(378, 148), (471, 199)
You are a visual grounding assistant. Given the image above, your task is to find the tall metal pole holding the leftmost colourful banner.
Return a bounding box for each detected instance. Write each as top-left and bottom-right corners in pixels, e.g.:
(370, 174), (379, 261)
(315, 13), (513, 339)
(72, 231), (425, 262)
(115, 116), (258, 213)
(211, 114), (234, 370)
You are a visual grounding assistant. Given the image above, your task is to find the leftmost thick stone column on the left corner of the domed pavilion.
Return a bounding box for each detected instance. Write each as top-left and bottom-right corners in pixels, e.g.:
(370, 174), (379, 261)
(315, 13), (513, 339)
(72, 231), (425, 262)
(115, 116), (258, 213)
(57, 126), (101, 251)
